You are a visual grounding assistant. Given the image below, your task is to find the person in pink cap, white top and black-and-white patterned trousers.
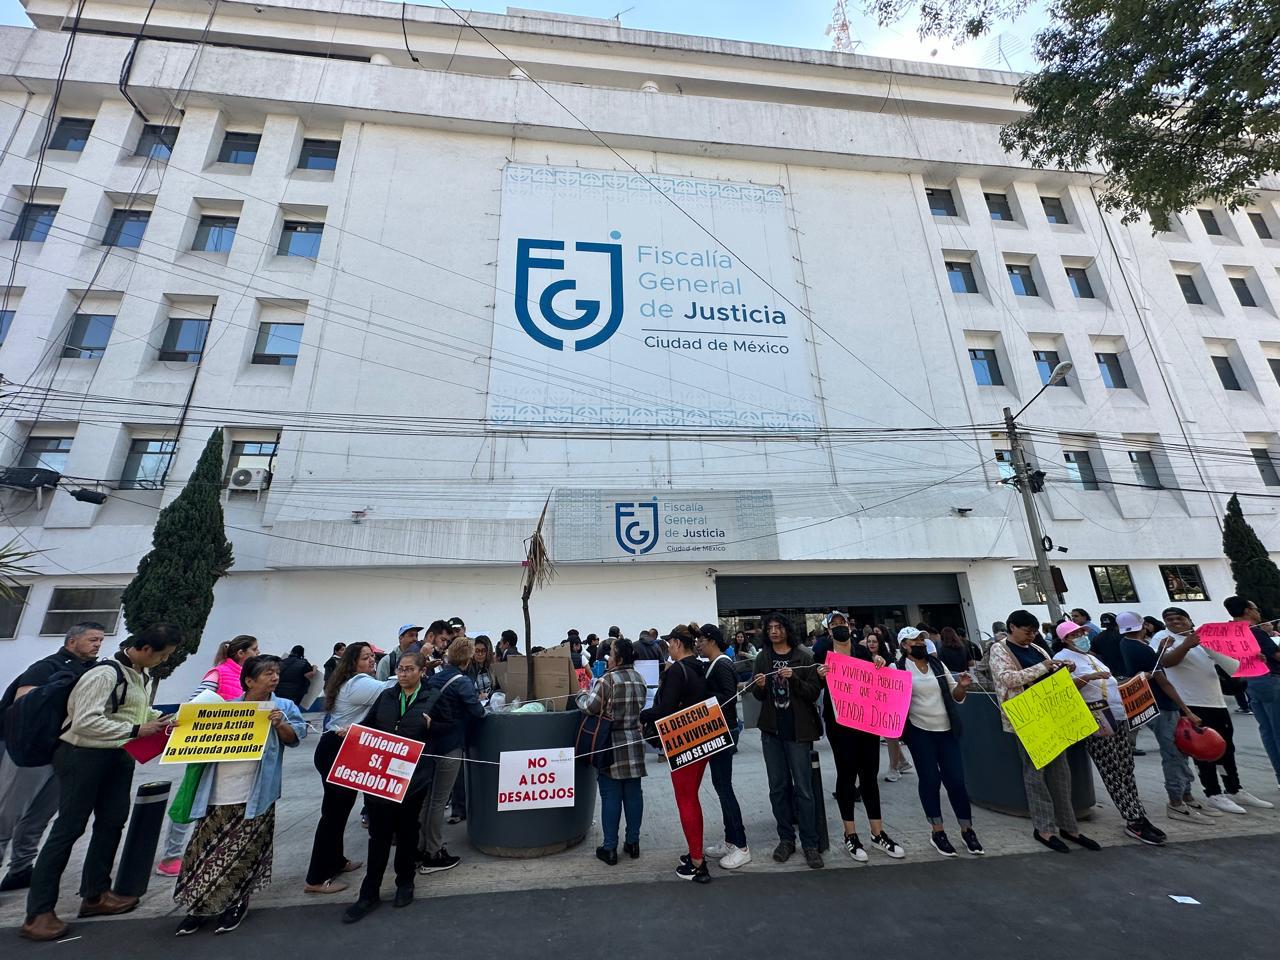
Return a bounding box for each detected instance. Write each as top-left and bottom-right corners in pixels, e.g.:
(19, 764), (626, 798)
(1055, 620), (1166, 846)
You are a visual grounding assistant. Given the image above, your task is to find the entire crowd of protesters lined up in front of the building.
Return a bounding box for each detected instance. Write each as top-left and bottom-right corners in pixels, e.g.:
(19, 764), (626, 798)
(0, 596), (1280, 941)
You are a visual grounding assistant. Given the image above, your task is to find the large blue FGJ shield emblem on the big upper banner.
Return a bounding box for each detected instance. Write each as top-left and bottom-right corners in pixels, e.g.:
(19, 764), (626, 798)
(516, 230), (622, 351)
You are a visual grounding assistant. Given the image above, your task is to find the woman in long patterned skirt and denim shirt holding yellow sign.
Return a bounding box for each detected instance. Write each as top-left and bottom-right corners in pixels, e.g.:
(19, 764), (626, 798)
(173, 657), (307, 937)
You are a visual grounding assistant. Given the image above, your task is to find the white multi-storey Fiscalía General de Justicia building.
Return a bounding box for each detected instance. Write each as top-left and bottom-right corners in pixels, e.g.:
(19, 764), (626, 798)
(0, 0), (1280, 698)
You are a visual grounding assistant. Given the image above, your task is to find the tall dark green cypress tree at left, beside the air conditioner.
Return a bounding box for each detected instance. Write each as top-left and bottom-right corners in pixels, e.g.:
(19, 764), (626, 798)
(123, 429), (234, 677)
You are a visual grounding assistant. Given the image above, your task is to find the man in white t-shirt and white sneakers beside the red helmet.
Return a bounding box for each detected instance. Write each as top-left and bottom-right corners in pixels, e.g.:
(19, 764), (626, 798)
(1147, 607), (1272, 813)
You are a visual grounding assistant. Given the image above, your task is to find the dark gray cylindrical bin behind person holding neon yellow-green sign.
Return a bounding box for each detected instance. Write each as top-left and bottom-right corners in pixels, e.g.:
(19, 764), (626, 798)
(959, 694), (1097, 819)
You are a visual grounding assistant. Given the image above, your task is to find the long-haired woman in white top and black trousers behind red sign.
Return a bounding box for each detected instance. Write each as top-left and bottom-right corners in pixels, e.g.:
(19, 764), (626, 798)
(305, 643), (396, 893)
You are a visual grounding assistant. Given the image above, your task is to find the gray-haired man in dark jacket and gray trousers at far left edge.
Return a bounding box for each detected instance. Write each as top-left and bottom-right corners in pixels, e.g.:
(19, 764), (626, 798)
(0, 621), (105, 891)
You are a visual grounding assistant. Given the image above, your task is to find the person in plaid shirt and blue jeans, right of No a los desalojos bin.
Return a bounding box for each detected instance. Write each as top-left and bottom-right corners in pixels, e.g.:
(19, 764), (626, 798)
(577, 637), (645, 867)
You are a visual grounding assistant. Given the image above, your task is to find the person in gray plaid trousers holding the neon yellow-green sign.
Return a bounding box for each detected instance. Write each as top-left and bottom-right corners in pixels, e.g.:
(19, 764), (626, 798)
(987, 611), (1102, 854)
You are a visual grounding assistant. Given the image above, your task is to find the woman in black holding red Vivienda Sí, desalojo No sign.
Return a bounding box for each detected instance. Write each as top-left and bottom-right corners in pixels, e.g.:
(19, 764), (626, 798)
(333, 652), (431, 923)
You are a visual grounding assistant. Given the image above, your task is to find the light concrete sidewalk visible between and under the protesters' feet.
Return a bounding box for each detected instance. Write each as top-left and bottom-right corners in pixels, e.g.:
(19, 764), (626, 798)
(0, 716), (1280, 927)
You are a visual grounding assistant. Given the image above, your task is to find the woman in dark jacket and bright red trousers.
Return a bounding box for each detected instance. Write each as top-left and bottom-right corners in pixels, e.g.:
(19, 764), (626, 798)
(640, 623), (712, 883)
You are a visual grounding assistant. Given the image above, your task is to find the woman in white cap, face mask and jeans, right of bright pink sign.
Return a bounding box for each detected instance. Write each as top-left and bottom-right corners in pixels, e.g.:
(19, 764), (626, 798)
(897, 637), (987, 856)
